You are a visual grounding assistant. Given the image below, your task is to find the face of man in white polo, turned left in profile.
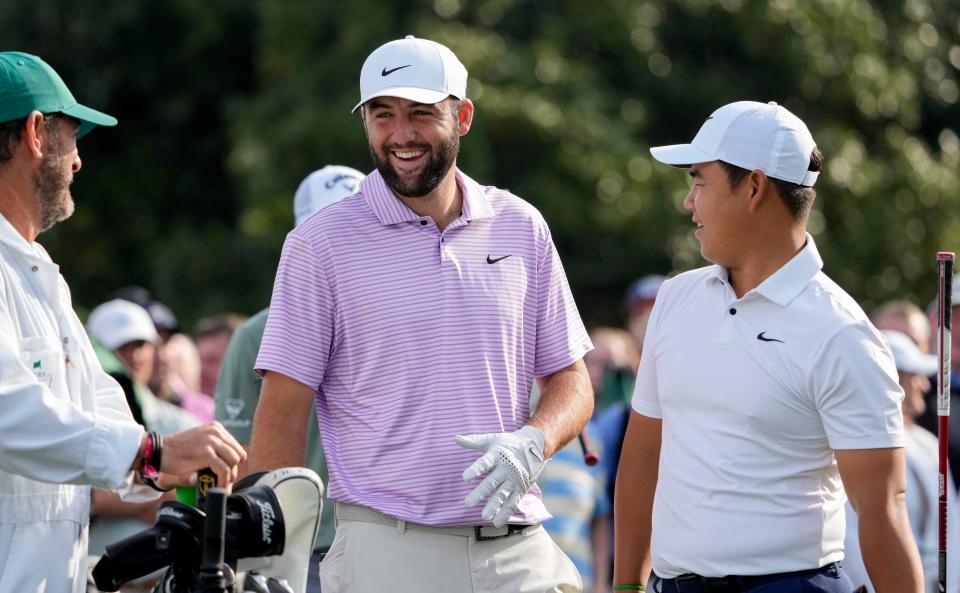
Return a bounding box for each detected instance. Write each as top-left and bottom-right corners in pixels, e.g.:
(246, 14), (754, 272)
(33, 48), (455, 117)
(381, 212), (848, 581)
(683, 161), (749, 267)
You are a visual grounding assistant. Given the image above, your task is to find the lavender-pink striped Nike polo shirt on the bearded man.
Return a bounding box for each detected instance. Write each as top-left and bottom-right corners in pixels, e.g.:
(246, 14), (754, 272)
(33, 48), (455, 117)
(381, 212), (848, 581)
(257, 171), (592, 525)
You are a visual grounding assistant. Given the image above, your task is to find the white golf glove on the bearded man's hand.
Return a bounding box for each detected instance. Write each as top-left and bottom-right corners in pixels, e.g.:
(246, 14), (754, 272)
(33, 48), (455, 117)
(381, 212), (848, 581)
(456, 425), (546, 527)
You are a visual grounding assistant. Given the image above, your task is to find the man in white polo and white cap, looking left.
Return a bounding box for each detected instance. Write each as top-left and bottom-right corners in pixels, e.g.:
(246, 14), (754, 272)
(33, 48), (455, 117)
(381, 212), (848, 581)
(614, 101), (923, 593)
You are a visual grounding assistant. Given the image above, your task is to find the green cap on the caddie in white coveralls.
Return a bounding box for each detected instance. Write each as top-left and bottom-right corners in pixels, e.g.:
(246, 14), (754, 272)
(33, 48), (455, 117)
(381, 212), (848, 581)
(0, 51), (117, 138)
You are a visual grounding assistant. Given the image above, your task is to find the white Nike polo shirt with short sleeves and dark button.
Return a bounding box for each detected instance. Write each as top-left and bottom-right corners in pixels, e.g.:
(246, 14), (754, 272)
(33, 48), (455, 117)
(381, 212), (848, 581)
(633, 235), (903, 578)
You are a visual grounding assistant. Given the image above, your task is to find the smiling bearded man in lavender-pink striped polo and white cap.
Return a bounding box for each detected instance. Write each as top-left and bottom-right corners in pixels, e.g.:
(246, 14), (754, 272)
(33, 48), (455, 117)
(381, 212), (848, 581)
(250, 37), (593, 593)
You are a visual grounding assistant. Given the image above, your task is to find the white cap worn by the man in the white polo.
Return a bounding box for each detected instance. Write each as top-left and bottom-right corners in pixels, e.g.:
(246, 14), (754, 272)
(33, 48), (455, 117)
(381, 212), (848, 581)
(650, 101), (820, 187)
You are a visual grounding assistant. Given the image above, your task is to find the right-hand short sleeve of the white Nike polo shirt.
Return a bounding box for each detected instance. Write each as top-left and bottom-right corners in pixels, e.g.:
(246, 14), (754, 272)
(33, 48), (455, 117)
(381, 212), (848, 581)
(809, 321), (904, 449)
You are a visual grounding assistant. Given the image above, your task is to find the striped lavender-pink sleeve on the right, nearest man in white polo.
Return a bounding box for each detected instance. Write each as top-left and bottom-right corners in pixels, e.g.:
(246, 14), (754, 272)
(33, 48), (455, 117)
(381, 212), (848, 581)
(533, 224), (593, 377)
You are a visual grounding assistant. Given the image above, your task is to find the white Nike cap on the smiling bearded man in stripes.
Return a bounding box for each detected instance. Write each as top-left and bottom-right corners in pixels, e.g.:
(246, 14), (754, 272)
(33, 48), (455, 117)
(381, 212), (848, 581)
(351, 35), (467, 113)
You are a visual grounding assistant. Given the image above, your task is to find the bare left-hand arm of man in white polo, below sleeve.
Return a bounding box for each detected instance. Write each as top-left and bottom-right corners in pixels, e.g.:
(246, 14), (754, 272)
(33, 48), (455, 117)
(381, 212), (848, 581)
(613, 412), (660, 585)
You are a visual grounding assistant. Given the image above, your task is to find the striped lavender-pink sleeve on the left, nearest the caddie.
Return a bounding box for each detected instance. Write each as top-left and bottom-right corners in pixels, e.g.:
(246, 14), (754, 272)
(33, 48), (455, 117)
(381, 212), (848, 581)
(256, 233), (336, 389)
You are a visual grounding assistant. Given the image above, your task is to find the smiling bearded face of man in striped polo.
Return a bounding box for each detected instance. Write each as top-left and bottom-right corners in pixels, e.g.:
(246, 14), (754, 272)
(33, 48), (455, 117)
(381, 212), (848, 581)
(362, 97), (473, 198)
